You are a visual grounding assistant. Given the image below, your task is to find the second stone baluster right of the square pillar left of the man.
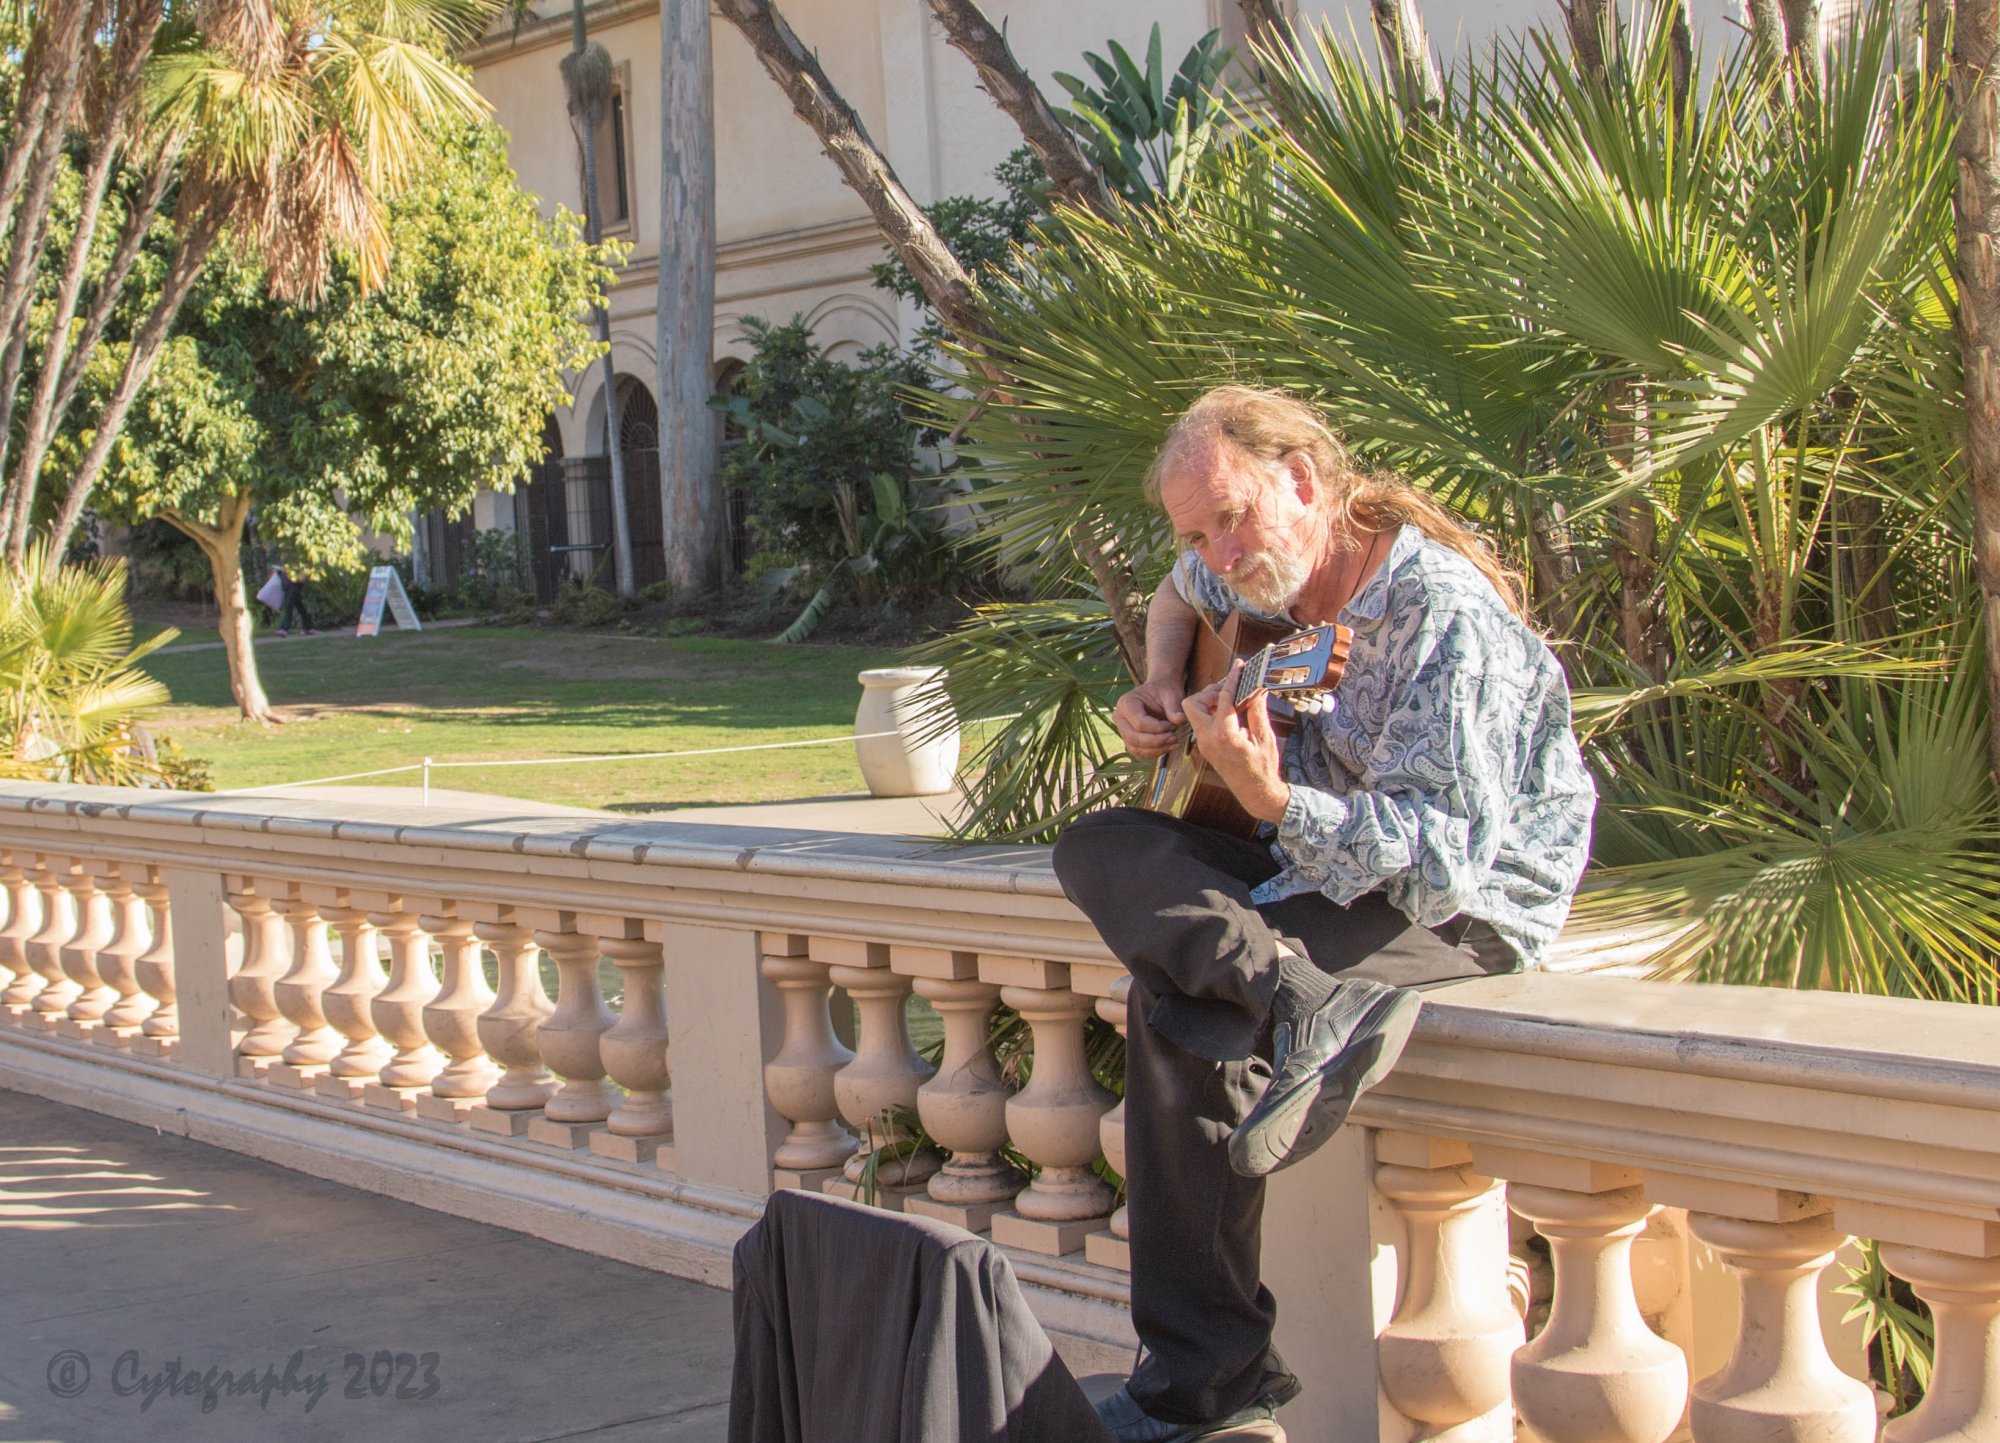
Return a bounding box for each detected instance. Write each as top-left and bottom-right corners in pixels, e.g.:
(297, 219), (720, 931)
(828, 937), (940, 1211)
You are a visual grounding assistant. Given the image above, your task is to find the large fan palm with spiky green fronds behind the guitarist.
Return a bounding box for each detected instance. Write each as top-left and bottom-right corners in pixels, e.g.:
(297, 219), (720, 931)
(928, 10), (2000, 999)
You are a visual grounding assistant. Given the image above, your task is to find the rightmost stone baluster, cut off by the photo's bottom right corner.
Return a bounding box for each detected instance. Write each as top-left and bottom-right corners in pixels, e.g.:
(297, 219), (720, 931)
(1882, 1243), (2000, 1443)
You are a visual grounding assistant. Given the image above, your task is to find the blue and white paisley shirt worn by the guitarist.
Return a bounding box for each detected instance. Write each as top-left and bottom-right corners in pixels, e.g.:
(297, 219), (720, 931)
(1174, 526), (1596, 967)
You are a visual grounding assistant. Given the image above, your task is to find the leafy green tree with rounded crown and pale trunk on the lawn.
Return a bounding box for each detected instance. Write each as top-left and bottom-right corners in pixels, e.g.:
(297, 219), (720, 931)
(86, 124), (610, 720)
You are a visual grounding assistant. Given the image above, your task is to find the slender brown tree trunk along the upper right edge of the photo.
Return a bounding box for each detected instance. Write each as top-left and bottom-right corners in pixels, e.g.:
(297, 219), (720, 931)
(1952, 0), (2000, 777)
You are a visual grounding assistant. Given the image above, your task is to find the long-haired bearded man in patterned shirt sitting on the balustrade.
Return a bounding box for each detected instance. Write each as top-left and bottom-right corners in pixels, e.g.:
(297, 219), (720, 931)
(1056, 386), (1594, 1443)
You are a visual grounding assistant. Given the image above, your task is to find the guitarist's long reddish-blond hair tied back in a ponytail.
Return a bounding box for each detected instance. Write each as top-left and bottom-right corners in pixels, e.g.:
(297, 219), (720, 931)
(1146, 386), (1528, 620)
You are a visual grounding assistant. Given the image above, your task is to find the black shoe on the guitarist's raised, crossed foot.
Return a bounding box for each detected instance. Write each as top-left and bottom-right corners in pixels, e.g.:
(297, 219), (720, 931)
(1230, 977), (1422, 1177)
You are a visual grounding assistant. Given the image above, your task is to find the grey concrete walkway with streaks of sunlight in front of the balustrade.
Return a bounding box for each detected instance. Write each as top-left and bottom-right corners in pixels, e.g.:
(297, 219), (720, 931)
(0, 1091), (732, 1443)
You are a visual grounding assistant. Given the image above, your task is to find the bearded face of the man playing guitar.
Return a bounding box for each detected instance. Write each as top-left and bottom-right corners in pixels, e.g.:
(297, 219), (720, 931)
(1160, 442), (1318, 612)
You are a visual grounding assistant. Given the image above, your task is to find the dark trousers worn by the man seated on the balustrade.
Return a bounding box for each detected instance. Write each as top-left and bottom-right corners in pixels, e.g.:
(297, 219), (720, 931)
(1056, 807), (1514, 1423)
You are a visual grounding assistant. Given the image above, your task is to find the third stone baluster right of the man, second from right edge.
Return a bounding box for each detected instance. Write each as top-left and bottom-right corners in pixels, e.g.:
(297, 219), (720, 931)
(1688, 1213), (1876, 1443)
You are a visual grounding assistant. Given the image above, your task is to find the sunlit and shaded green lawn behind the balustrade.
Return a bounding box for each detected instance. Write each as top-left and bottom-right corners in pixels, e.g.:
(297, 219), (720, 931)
(146, 628), (894, 811)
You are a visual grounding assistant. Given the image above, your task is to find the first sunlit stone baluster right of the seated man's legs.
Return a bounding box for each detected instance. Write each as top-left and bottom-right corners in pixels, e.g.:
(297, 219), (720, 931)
(1374, 1133), (1524, 1443)
